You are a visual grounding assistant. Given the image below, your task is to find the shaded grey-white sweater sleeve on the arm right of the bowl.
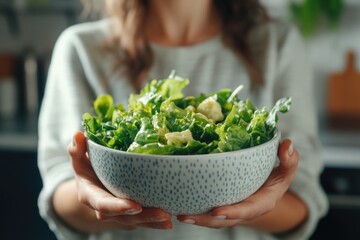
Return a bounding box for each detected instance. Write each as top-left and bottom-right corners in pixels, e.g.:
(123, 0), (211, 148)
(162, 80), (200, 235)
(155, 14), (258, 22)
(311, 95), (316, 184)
(274, 25), (328, 240)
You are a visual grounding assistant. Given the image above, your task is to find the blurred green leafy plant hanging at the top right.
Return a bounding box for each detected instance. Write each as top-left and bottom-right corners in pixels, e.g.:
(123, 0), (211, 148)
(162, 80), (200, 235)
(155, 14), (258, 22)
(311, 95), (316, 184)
(289, 0), (344, 36)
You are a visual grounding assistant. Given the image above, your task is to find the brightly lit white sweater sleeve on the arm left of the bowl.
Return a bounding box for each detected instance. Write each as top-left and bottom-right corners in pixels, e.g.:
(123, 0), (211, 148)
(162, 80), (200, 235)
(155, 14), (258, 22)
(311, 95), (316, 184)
(38, 28), (91, 240)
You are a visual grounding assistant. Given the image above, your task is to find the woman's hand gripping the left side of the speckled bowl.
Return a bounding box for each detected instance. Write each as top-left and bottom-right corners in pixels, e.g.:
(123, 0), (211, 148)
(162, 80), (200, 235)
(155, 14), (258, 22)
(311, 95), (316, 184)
(68, 132), (172, 230)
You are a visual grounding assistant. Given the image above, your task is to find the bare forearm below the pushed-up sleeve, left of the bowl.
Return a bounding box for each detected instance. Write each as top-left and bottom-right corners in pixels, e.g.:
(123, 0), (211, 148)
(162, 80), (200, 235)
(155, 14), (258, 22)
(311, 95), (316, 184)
(52, 179), (114, 233)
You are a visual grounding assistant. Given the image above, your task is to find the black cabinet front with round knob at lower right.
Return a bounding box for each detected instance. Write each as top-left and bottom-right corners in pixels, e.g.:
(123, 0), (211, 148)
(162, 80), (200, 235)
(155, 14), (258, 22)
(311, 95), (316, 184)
(311, 166), (360, 240)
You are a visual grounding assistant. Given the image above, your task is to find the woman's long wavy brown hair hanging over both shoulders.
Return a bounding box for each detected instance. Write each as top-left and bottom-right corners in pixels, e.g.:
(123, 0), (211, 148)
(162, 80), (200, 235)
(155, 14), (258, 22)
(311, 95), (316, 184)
(102, 0), (269, 90)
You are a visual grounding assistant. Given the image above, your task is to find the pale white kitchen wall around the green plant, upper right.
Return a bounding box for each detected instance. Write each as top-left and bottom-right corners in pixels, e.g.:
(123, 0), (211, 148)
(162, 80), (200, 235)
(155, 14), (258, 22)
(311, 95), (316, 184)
(263, 0), (360, 117)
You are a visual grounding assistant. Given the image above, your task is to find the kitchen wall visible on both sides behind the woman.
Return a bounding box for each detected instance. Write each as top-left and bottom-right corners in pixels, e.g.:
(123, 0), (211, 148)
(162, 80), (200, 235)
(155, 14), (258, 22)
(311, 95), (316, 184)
(0, 0), (360, 115)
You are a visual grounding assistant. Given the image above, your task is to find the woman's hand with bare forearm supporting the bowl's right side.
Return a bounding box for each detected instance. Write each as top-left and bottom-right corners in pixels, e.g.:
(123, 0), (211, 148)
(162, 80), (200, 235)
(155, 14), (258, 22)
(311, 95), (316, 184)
(177, 140), (307, 232)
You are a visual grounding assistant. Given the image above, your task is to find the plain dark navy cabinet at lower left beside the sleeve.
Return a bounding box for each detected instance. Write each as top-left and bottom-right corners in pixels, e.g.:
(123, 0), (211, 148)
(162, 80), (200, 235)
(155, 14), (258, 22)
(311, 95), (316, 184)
(0, 150), (55, 240)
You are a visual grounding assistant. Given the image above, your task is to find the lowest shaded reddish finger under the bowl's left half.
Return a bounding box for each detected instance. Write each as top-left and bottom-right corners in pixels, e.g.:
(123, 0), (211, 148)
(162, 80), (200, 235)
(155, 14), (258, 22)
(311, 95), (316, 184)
(100, 208), (171, 225)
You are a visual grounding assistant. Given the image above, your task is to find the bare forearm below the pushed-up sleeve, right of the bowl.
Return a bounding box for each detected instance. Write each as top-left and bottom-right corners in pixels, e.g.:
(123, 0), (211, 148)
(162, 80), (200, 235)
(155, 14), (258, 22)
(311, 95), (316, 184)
(246, 191), (308, 233)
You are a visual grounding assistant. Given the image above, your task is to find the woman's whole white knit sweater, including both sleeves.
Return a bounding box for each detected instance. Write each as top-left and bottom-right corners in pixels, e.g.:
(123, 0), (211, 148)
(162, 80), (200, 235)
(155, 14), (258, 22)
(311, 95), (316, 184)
(38, 20), (328, 240)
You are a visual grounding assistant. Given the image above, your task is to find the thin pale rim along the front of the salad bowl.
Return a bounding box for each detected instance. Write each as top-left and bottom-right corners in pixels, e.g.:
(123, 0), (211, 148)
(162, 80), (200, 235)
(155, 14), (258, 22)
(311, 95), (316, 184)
(85, 128), (281, 159)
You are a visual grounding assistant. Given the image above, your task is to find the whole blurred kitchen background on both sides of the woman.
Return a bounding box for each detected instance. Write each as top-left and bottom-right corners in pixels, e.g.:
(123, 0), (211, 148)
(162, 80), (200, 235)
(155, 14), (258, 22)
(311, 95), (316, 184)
(0, 0), (360, 240)
